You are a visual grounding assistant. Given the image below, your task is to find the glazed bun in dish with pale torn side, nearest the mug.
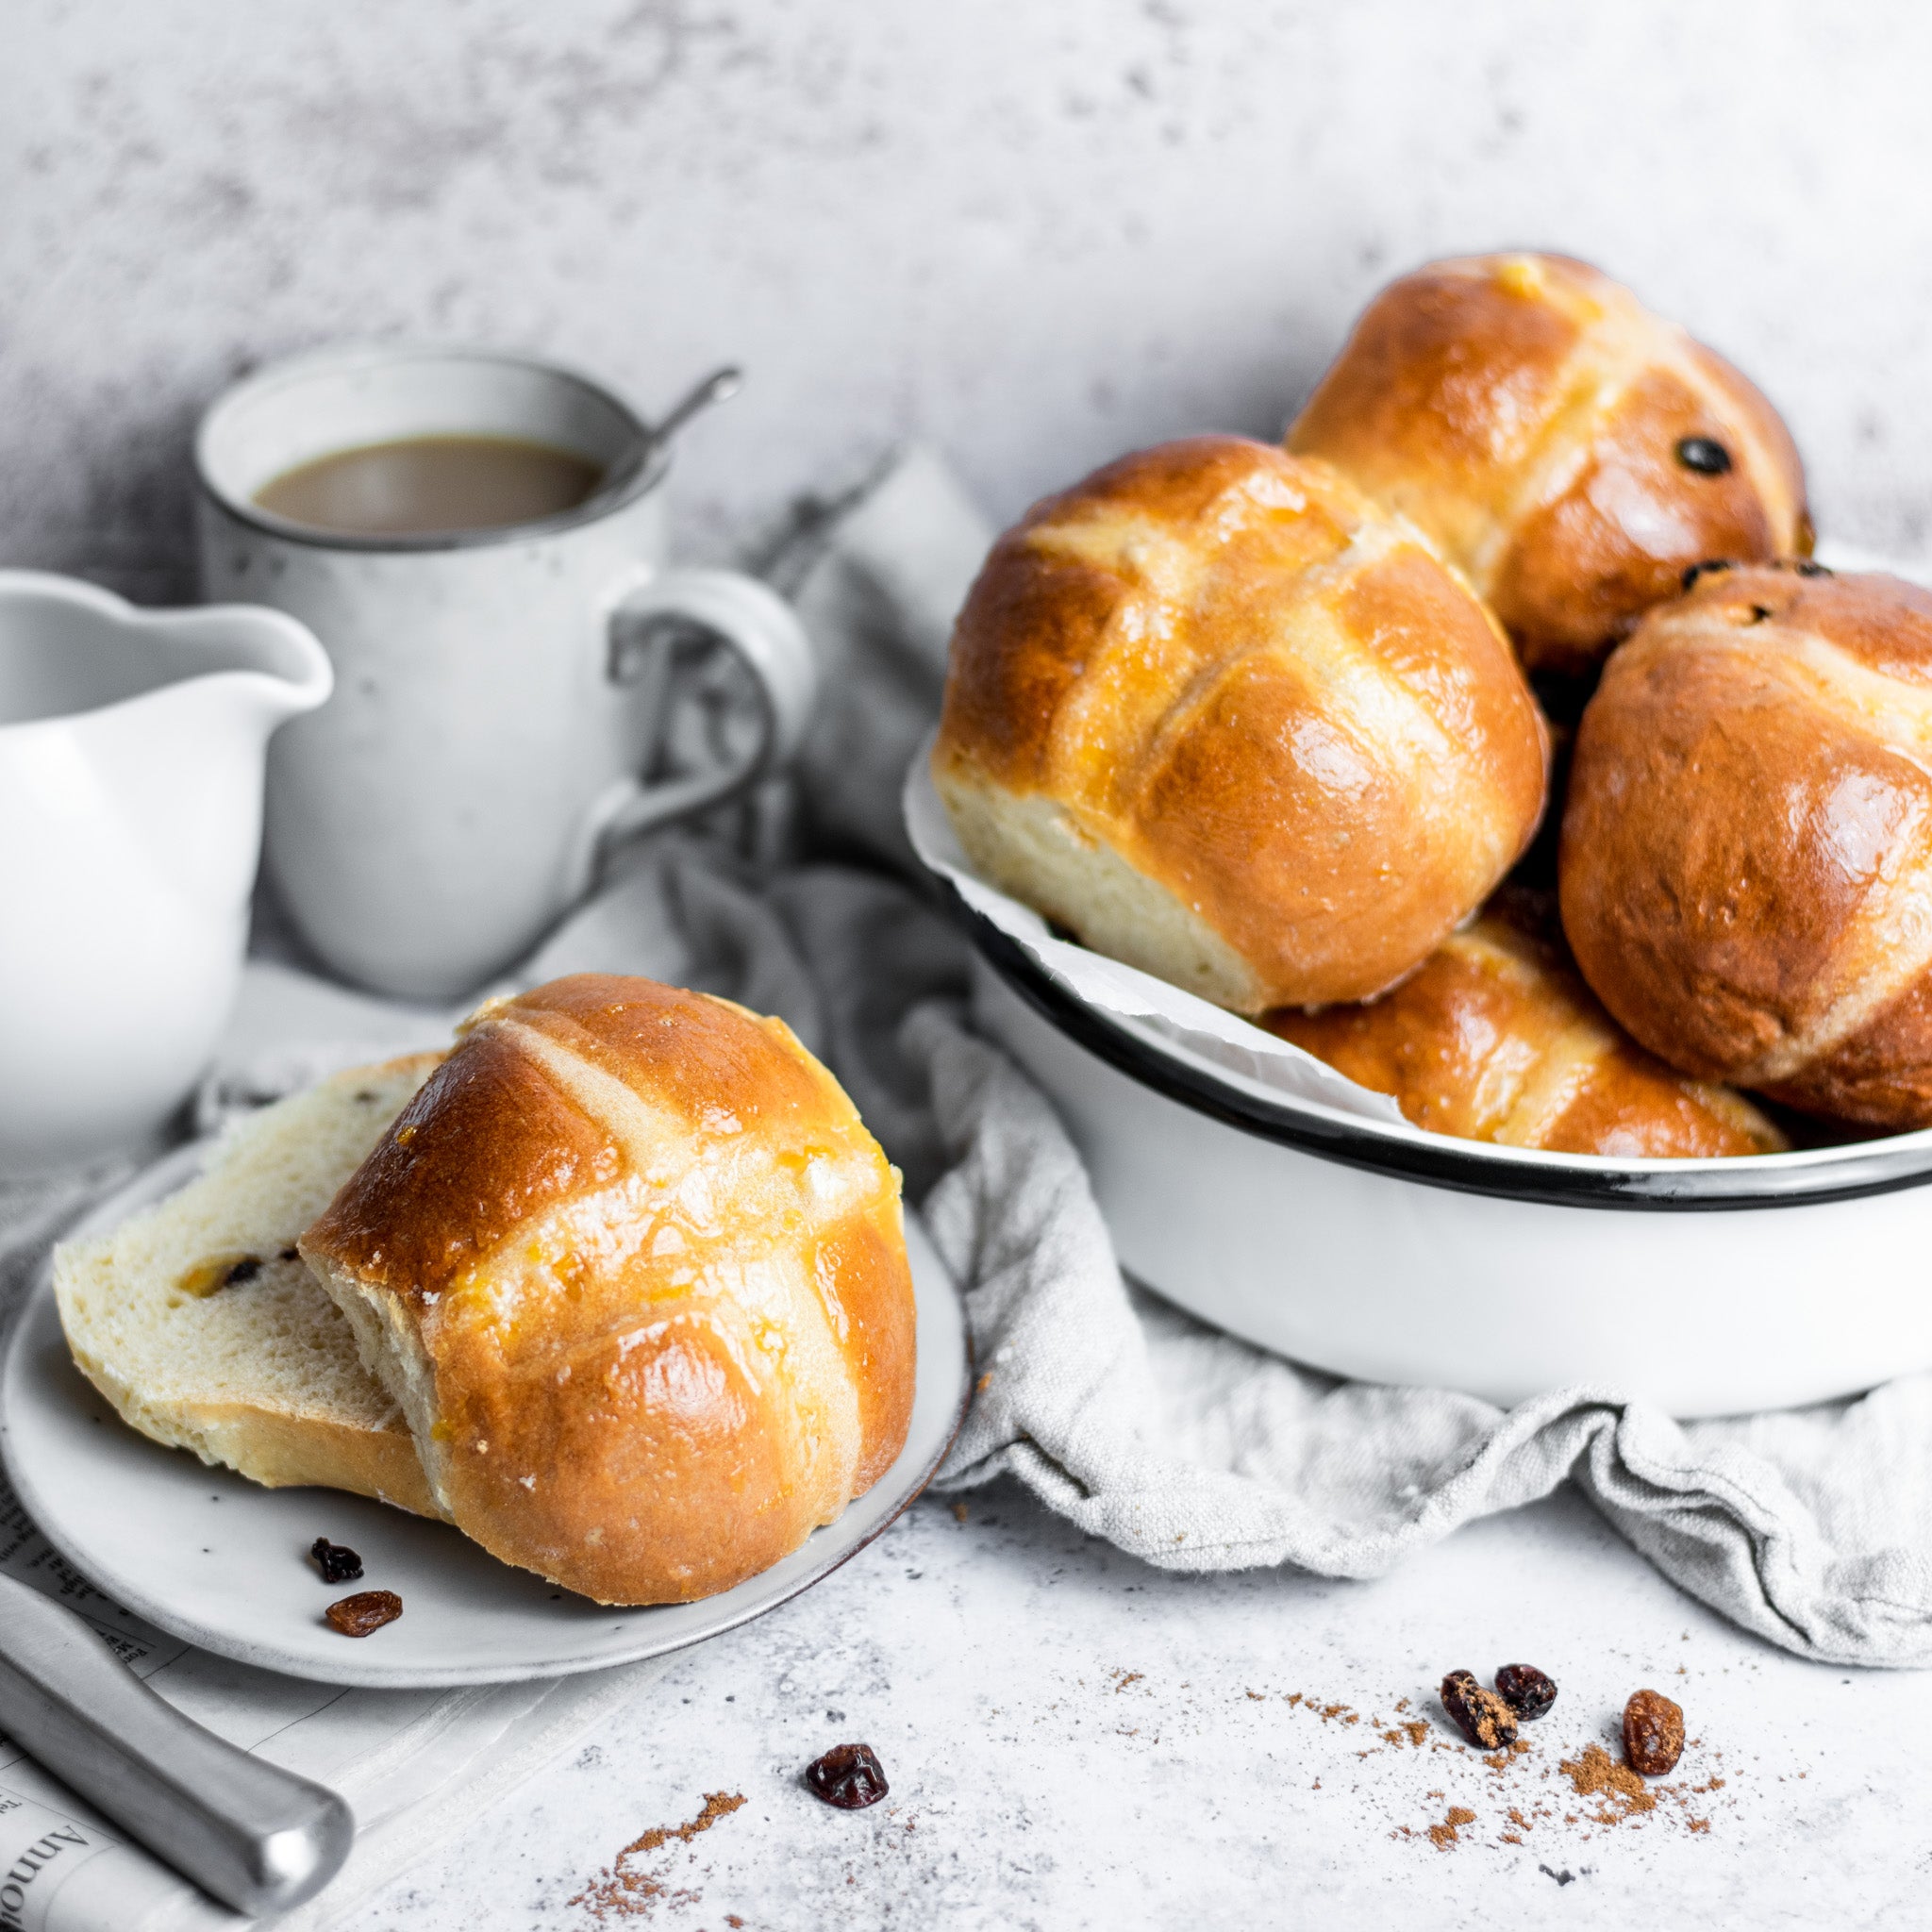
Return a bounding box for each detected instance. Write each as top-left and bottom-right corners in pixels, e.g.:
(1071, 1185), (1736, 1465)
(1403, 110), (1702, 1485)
(933, 437), (1547, 1012)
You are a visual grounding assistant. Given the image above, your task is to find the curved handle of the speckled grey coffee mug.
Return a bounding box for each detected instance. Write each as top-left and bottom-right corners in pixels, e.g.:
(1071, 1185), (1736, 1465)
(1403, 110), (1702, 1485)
(579, 570), (819, 887)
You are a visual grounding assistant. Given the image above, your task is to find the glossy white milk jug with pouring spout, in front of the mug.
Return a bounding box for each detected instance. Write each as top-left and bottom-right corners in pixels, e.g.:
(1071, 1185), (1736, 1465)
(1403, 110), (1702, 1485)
(0, 570), (328, 1178)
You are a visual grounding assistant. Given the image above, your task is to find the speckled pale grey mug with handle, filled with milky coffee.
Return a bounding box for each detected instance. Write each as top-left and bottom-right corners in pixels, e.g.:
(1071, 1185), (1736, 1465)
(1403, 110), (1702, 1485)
(195, 346), (815, 999)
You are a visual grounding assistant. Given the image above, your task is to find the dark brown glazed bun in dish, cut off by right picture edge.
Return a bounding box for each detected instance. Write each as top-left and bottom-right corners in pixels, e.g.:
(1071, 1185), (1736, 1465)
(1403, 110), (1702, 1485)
(1559, 566), (1932, 1126)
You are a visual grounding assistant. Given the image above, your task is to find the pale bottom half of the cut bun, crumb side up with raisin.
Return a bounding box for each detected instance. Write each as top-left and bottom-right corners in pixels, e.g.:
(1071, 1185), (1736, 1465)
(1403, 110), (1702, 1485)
(54, 1053), (442, 1517)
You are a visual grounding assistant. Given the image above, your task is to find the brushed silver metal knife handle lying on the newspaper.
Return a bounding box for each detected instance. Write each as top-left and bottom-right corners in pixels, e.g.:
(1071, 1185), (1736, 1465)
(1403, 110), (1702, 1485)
(0, 1576), (356, 1915)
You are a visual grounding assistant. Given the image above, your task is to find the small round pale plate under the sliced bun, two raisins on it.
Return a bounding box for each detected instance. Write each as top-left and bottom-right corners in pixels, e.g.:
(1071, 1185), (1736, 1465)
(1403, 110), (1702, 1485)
(0, 1145), (968, 1689)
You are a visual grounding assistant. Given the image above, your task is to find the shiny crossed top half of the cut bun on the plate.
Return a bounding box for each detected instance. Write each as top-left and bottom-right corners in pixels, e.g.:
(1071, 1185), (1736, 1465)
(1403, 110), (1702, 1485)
(301, 974), (914, 1604)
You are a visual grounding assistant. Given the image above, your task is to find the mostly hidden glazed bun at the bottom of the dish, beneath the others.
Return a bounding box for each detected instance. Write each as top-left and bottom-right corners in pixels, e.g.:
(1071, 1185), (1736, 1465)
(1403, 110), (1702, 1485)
(1263, 889), (1785, 1159)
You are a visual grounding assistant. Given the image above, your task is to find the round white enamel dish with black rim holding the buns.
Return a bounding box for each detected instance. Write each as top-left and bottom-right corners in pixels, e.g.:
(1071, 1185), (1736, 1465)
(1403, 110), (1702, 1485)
(907, 699), (1932, 1416)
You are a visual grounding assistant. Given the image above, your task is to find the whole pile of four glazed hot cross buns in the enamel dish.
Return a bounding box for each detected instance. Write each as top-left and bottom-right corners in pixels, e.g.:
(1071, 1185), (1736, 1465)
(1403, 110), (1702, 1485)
(946, 255), (1932, 1158)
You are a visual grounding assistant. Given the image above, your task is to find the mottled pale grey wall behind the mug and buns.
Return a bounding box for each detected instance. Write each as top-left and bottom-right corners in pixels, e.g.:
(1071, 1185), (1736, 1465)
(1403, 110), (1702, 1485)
(0, 0), (1932, 601)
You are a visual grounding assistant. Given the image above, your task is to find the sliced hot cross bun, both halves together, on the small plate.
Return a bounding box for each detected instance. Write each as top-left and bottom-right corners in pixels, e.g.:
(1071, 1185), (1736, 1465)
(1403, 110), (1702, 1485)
(54, 974), (916, 1604)
